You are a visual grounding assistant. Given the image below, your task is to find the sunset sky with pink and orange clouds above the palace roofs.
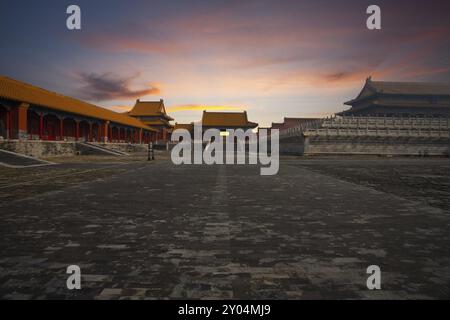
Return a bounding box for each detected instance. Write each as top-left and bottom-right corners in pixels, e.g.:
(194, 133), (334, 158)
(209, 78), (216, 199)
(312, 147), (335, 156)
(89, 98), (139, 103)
(0, 0), (450, 126)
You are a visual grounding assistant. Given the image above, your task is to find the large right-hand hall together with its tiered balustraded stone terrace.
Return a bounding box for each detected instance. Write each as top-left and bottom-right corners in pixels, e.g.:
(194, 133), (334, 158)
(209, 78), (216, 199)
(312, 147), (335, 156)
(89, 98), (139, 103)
(279, 77), (450, 156)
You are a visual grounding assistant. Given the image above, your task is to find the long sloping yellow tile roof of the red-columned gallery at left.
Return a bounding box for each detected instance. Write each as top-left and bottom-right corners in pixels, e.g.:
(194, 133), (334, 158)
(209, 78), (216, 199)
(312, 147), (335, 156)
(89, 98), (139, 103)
(0, 76), (156, 131)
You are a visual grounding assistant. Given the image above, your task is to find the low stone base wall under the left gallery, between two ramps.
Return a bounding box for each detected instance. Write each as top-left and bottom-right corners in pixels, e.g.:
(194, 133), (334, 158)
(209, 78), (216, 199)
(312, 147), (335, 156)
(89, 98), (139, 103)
(0, 140), (77, 158)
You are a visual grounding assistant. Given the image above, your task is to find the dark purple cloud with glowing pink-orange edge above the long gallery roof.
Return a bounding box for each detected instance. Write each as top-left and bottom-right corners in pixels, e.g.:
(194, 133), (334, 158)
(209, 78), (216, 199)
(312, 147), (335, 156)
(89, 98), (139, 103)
(79, 73), (161, 101)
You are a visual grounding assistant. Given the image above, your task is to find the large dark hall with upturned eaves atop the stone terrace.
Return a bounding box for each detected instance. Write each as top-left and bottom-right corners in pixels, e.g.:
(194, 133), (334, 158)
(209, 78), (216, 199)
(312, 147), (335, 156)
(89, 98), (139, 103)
(338, 77), (450, 117)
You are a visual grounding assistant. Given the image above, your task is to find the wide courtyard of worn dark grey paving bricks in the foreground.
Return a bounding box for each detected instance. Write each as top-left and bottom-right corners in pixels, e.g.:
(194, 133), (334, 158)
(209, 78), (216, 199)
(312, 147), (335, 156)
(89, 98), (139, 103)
(0, 158), (450, 299)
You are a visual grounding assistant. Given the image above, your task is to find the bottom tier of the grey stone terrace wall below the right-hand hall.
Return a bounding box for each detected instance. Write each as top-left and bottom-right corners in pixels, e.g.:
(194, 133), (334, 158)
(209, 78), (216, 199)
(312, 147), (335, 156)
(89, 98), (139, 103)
(301, 136), (450, 156)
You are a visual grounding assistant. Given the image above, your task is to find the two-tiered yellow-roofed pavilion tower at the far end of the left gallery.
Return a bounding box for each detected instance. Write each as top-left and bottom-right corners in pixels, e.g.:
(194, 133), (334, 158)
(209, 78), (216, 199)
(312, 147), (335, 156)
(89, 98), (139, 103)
(126, 99), (174, 142)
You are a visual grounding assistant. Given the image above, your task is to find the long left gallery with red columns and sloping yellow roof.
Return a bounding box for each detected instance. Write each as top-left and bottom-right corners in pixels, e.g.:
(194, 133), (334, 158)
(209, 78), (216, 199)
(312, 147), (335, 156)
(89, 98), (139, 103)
(0, 76), (160, 143)
